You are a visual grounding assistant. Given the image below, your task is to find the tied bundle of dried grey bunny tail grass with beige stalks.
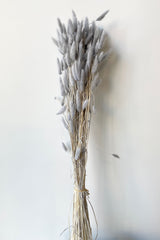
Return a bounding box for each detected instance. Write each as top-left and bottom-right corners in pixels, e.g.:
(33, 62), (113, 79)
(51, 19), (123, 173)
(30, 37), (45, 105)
(53, 11), (110, 240)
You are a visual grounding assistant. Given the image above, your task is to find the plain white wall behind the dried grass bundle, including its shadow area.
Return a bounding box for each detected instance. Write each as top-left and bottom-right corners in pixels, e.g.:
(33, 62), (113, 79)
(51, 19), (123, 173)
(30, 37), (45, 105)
(0, 0), (160, 240)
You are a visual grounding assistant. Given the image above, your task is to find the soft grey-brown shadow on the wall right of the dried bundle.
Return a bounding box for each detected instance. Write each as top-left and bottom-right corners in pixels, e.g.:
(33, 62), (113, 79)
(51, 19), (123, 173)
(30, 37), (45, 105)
(92, 31), (120, 240)
